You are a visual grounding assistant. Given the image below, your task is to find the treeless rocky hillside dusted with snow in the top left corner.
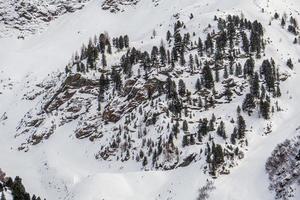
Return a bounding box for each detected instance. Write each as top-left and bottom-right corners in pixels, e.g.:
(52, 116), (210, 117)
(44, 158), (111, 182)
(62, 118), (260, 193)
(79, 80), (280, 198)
(0, 0), (88, 39)
